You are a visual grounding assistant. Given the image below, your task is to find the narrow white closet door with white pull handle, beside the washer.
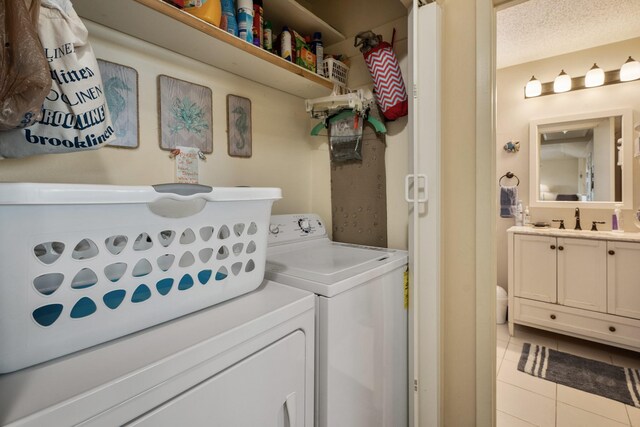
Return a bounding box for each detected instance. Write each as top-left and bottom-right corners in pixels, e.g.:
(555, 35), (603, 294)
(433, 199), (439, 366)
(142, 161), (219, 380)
(405, 0), (442, 427)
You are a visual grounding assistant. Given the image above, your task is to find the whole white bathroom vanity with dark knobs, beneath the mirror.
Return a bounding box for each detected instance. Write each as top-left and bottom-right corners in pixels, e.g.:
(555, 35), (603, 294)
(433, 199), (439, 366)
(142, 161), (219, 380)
(507, 226), (640, 351)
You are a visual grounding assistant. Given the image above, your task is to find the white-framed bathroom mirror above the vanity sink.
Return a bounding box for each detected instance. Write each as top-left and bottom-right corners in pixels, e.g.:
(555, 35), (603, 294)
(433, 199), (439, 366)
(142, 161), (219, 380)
(529, 109), (633, 209)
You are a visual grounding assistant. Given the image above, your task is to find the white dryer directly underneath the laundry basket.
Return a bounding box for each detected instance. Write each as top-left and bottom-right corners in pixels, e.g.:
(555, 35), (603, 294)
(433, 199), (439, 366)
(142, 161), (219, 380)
(0, 281), (316, 427)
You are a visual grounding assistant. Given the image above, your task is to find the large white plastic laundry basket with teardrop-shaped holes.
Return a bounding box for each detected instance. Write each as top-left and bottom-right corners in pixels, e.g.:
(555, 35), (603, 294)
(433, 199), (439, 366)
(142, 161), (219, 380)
(0, 183), (281, 373)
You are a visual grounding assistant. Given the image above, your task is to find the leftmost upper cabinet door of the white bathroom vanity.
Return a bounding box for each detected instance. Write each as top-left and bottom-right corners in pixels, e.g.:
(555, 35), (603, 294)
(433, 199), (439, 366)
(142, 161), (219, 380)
(513, 234), (557, 303)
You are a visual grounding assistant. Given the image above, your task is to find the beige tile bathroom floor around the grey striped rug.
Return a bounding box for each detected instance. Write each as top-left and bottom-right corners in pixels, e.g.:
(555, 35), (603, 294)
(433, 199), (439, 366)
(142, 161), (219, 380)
(496, 324), (640, 427)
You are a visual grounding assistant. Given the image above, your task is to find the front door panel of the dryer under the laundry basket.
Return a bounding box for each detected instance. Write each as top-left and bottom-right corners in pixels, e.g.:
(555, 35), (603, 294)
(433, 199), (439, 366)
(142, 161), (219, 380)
(128, 331), (313, 427)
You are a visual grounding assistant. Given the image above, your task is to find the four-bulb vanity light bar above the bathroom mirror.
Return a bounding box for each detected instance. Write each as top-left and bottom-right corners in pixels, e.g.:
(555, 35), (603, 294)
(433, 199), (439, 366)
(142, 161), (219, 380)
(524, 57), (640, 98)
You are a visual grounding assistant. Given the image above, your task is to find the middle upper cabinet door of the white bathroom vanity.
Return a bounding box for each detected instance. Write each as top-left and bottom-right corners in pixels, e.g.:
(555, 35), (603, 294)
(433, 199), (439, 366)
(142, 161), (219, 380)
(558, 237), (607, 313)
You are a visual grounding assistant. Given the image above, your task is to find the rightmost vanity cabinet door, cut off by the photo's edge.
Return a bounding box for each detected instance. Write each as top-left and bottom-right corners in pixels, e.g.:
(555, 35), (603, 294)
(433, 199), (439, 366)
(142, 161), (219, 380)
(607, 242), (640, 319)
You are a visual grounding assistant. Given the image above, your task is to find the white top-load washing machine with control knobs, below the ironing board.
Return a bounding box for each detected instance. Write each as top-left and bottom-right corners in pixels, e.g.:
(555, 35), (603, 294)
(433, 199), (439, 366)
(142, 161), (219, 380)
(265, 214), (408, 427)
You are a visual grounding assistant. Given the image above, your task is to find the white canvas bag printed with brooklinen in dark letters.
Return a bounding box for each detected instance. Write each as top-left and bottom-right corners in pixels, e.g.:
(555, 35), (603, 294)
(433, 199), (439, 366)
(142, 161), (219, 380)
(0, 0), (115, 157)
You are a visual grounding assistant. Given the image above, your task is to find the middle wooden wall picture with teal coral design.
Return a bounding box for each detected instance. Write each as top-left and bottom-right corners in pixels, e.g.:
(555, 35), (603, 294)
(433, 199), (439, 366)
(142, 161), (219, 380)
(158, 75), (213, 153)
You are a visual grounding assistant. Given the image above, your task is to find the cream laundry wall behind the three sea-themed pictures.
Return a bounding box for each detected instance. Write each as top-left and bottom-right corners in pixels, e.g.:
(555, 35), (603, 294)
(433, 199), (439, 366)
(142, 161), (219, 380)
(0, 21), (322, 213)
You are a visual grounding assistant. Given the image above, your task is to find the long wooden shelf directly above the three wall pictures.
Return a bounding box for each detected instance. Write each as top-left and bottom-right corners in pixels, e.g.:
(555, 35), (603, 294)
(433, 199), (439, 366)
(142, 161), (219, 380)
(73, 0), (339, 98)
